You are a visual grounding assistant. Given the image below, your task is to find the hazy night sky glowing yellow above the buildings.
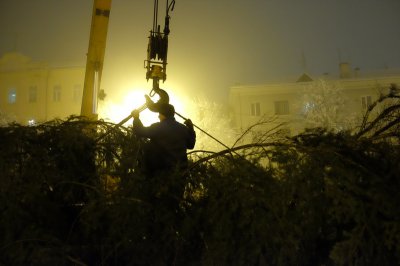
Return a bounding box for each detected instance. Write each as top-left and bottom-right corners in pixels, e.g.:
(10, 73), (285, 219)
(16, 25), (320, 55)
(0, 0), (400, 101)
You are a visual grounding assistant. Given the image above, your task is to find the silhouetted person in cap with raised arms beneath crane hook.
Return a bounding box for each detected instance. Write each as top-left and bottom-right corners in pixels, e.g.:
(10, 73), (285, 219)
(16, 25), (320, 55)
(132, 103), (196, 176)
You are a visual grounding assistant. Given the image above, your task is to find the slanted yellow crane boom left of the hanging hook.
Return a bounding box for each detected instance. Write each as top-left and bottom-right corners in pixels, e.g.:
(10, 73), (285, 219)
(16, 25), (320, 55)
(81, 0), (111, 120)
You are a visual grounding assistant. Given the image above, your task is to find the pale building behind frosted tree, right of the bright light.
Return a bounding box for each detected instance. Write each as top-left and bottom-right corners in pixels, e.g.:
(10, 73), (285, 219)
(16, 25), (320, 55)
(229, 63), (400, 135)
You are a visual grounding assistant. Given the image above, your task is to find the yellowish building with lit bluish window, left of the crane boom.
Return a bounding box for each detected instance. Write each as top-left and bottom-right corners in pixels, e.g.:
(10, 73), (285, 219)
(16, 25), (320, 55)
(0, 53), (85, 125)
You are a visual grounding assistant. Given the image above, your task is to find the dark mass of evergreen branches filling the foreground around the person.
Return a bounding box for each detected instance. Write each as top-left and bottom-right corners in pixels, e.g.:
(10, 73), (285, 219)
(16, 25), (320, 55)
(0, 90), (400, 265)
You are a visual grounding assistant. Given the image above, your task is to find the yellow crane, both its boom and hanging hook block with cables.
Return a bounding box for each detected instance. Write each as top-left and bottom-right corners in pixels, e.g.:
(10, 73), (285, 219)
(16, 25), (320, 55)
(81, 0), (175, 120)
